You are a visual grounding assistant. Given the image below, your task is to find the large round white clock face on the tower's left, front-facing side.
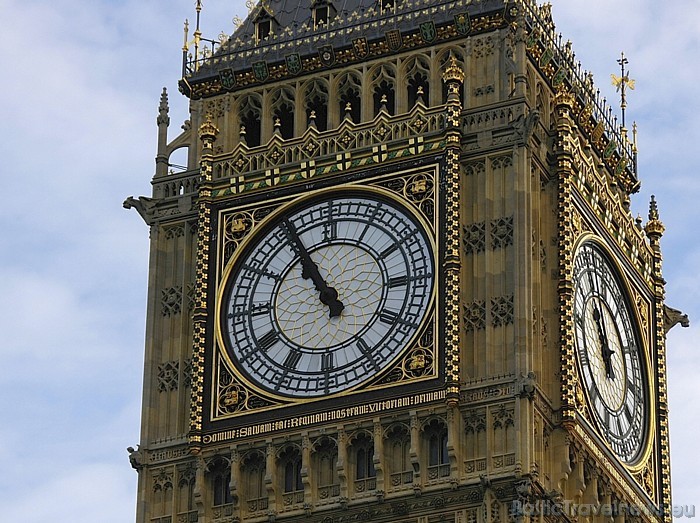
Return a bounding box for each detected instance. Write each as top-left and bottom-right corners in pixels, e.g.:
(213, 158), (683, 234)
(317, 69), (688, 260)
(220, 190), (435, 397)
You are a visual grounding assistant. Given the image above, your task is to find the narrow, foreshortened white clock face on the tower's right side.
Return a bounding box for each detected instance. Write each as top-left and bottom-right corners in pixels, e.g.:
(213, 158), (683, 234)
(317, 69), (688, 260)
(574, 242), (647, 463)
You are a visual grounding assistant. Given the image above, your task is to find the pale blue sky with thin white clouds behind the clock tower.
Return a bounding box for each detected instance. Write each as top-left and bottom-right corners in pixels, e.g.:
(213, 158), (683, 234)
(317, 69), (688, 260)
(0, 0), (700, 523)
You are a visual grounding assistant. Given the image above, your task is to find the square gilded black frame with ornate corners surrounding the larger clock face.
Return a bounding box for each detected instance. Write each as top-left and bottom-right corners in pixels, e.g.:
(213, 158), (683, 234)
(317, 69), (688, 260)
(207, 161), (444, 424)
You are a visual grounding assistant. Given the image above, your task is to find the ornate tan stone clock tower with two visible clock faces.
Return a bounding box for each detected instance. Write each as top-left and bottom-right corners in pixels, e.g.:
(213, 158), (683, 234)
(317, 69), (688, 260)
(125, 0), (684, 523)
